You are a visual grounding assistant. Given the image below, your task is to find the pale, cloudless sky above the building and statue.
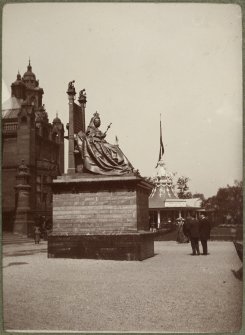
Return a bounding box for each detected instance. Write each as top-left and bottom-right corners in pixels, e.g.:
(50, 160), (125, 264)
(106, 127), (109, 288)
(2, 3), (242, 198)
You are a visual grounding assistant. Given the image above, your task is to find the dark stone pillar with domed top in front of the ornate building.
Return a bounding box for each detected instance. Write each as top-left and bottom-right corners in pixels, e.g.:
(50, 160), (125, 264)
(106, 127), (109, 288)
(14, 160), (34, 236)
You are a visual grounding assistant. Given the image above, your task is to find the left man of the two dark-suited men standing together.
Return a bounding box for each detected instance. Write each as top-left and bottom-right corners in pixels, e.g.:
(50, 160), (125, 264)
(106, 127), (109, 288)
(183, 216), (200, 255)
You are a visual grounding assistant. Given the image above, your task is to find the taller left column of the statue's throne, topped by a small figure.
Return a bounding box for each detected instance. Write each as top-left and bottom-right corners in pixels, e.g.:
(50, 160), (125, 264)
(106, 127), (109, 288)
(66, 80), (76, 174)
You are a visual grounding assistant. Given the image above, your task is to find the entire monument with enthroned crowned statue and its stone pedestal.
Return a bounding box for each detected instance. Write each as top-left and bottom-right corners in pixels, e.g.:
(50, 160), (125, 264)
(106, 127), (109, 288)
(48, 80), (154, 260)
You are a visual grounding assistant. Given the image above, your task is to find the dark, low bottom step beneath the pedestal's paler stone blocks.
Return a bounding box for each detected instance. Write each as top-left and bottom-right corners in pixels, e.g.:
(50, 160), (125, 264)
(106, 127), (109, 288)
(48, 232), (154, 261)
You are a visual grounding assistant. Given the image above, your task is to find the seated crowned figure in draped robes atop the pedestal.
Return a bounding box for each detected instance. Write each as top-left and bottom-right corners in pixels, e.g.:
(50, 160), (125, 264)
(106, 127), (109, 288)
(76, 112), (135, 176)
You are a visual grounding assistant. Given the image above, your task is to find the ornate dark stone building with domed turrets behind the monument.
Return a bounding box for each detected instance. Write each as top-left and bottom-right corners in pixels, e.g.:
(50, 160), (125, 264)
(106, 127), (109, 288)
(2, 61), (64, 235)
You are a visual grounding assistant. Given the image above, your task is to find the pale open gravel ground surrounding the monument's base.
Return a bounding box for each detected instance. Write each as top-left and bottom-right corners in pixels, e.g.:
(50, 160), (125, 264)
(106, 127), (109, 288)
(3, 241), (242, 333)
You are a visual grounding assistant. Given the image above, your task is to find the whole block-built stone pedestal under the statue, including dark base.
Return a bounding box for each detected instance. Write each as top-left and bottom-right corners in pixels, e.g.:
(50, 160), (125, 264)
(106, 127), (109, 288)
(48, 174), (154, 260)
